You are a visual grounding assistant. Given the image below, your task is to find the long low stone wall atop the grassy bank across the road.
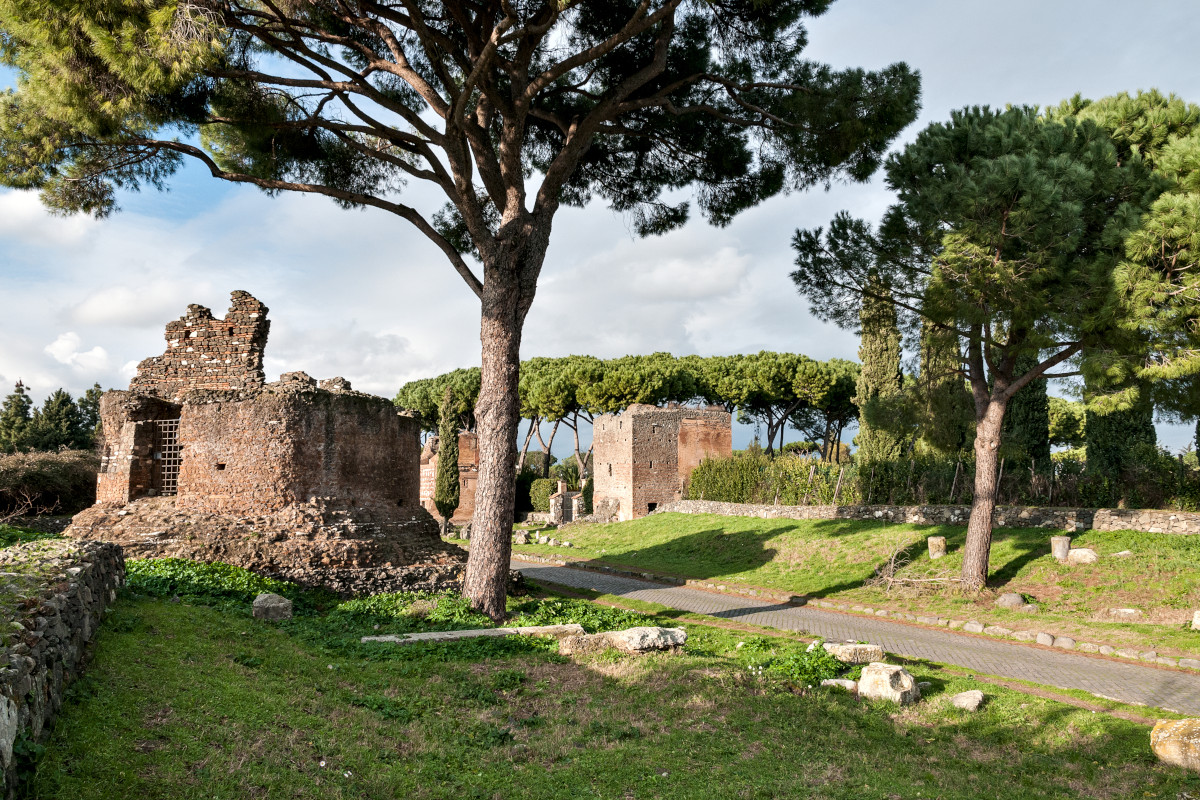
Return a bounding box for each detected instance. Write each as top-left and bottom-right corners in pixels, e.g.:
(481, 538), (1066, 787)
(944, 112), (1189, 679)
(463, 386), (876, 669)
(654, 500), (1200, 534)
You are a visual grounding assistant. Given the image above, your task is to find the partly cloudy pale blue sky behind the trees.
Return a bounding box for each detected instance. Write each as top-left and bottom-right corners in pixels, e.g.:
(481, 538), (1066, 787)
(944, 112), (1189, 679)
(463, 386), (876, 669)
(0, 0), (1200, 453)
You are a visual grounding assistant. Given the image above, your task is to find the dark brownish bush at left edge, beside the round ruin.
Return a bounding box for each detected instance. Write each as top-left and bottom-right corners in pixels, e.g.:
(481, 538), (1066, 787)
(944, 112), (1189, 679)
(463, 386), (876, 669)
(0, 450), (100, 515)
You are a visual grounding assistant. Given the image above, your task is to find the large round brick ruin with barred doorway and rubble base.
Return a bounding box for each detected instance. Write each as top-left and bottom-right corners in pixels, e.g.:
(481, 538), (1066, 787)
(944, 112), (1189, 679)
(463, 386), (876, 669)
(66, 291), (466, 594)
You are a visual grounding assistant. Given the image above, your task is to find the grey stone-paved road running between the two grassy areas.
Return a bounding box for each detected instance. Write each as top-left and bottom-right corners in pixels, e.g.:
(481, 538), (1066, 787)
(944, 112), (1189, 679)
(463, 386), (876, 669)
(512, 559), (1200, 715)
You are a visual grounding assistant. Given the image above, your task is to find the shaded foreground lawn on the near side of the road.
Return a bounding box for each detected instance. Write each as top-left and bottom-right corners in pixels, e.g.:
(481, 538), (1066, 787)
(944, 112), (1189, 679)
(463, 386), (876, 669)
(28, 597), (1194, 800)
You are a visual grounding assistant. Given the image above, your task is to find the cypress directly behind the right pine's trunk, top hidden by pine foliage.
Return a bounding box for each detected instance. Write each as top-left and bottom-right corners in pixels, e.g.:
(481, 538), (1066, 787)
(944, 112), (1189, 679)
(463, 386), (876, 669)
(917, 320), (974, 456)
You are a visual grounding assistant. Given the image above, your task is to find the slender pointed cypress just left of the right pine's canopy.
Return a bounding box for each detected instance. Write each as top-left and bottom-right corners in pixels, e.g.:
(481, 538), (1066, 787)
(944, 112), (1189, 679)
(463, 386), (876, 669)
(854, 276), (905, 462)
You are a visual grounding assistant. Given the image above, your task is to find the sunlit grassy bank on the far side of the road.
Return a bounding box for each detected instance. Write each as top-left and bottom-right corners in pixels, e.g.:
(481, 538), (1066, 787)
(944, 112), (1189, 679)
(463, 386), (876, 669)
(514, 513), (1200, 654)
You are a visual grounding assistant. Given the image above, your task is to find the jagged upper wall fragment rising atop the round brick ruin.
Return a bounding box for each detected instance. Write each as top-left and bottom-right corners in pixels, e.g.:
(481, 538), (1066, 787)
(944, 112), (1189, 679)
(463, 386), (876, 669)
(130, 291), (270, 399)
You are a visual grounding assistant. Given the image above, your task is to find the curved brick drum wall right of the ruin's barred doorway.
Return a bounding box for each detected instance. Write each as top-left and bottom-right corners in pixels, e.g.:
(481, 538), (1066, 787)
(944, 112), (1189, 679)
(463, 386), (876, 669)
(176, 381), (420, 515)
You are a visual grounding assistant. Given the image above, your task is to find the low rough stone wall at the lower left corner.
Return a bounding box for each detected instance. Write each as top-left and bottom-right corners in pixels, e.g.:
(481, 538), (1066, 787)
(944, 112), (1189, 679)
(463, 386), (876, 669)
(0, 540), (125, 798)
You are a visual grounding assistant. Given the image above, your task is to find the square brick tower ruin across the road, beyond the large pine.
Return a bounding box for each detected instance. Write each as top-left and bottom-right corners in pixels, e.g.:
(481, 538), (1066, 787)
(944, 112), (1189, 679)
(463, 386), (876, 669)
(592, 404), (733, 521)
